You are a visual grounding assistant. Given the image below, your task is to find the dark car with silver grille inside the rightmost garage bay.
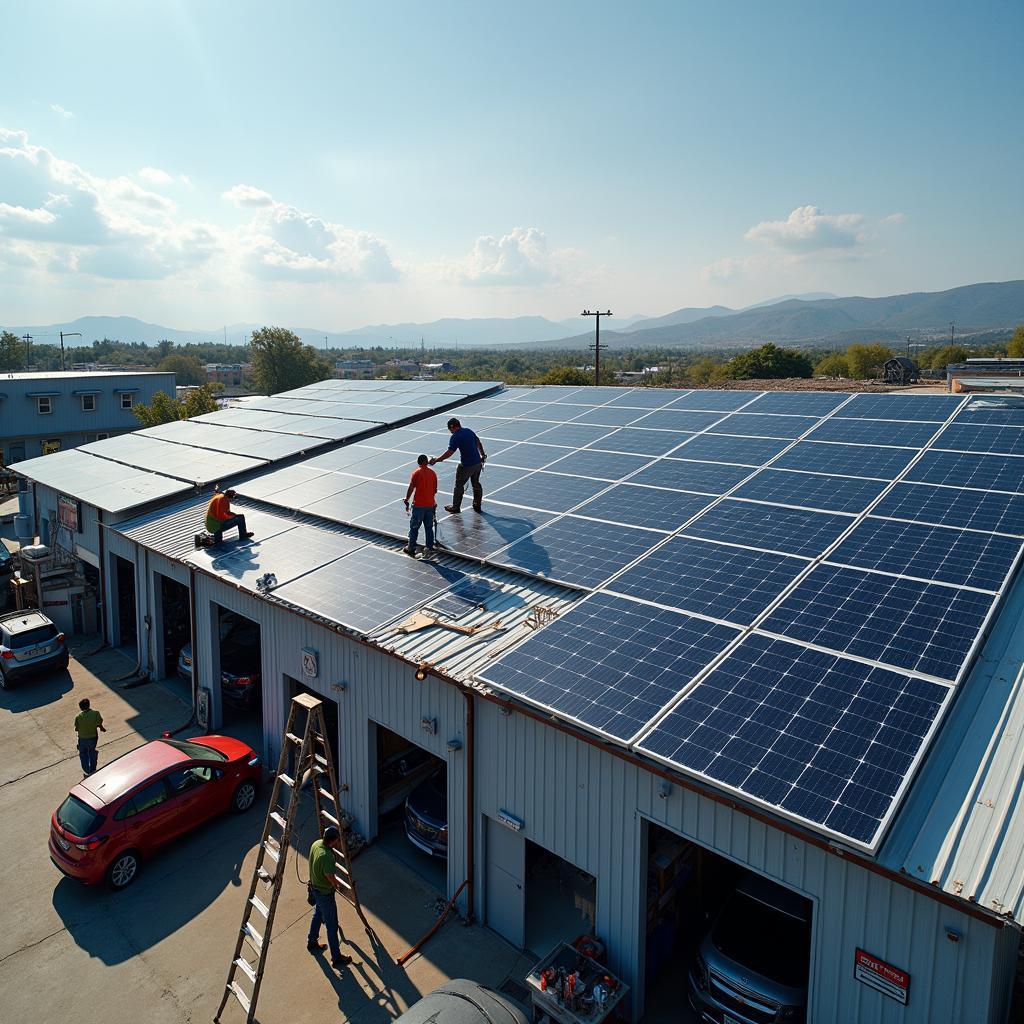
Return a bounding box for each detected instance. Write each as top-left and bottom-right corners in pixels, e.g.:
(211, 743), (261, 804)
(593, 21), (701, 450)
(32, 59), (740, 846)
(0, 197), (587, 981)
(689, 874), (811, 1024)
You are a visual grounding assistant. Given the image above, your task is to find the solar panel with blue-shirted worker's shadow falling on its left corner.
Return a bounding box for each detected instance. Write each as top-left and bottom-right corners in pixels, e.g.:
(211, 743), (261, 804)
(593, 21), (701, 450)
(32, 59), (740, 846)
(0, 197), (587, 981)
(494, 518), (665, 587)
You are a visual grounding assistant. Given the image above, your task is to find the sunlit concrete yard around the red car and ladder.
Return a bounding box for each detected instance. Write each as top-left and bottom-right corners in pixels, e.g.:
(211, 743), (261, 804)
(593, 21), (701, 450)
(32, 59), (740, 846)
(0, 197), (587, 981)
(0, 640), (530, 1024)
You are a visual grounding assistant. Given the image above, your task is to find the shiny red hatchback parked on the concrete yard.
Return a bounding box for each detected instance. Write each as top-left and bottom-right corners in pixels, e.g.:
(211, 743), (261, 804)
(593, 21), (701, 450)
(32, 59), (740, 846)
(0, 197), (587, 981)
(49, 736), (260, 889)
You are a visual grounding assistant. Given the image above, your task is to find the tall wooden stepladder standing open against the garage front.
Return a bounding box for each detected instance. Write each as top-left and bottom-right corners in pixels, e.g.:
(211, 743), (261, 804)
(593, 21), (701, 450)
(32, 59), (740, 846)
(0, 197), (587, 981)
(213, 693), (370, 1024)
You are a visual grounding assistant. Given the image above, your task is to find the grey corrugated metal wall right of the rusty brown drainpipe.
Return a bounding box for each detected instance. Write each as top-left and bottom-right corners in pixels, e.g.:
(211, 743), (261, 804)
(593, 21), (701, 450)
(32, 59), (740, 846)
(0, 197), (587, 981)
(476, 701), (1016, 1024)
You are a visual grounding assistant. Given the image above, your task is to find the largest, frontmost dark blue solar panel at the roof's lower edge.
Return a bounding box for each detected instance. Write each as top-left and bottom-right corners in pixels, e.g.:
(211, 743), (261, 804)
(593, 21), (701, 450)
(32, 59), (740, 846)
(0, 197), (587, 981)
(639, 634), (950, 849)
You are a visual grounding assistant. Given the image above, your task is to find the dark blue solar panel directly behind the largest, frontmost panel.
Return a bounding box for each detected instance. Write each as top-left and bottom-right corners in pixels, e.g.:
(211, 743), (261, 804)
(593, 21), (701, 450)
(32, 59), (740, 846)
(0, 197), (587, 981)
(762, 565), (992, 680)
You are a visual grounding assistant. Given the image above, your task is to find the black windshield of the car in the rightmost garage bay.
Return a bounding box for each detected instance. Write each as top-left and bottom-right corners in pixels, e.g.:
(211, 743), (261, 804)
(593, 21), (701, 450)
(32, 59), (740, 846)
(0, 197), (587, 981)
(711, 892), (810, 988)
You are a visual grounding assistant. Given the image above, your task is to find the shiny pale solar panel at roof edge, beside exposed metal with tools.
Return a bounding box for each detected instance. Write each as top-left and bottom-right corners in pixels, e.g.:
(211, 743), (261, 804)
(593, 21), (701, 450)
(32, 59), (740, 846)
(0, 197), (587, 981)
(274, 547), (464, 634)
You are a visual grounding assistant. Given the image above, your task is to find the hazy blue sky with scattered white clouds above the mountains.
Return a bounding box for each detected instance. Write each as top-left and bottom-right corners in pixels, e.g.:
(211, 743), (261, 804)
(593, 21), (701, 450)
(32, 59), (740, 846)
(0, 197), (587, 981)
(0, 0), (1024, 331)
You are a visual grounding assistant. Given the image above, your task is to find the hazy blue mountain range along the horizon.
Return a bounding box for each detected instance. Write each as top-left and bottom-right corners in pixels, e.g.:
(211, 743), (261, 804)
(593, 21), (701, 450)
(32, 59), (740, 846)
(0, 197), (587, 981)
(7, 281), (1024, 349)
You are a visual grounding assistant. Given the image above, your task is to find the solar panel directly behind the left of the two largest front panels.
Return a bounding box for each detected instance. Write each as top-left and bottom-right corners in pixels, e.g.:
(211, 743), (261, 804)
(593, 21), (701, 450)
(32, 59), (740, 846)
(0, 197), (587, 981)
(610, 538), (808, 625)
